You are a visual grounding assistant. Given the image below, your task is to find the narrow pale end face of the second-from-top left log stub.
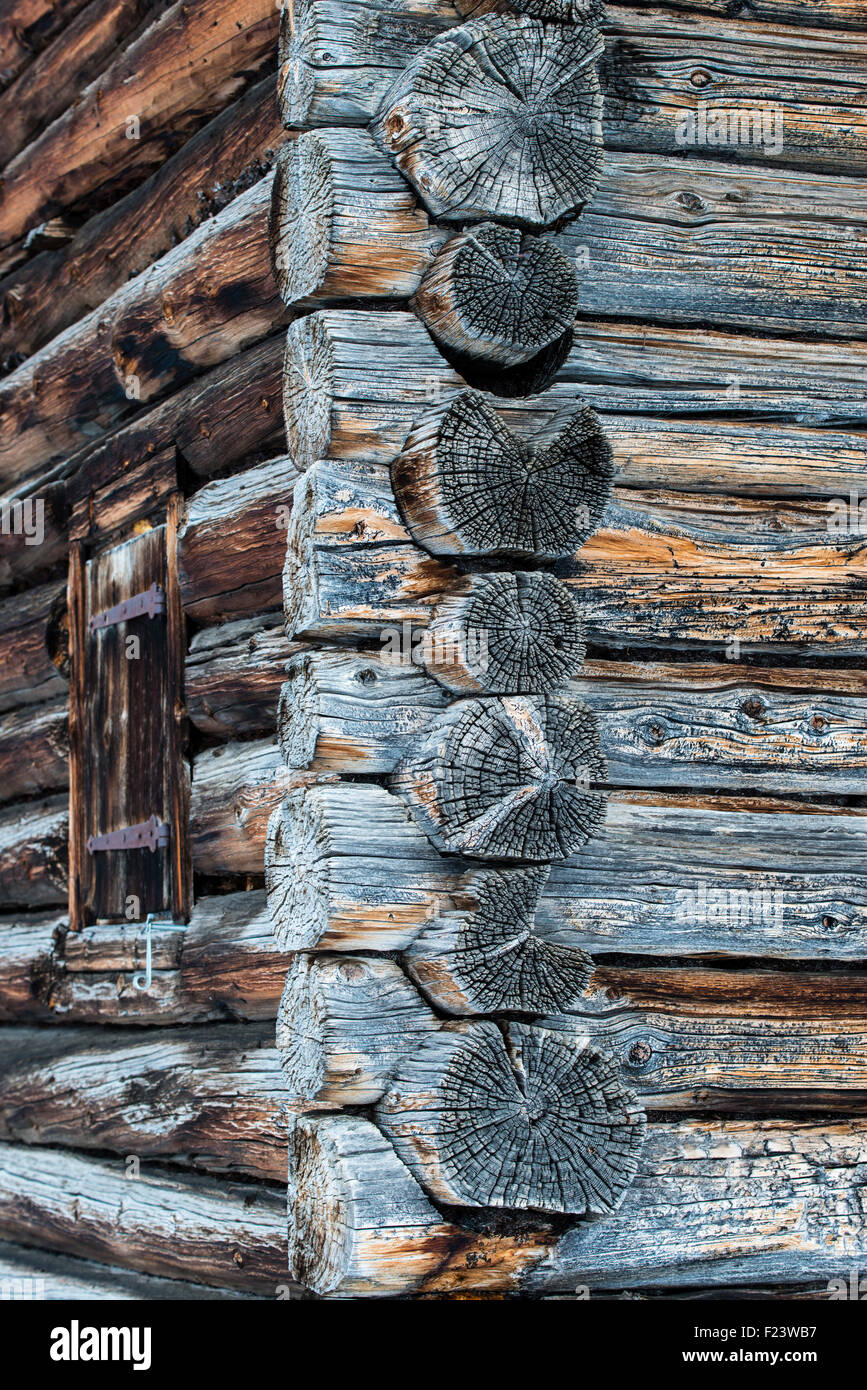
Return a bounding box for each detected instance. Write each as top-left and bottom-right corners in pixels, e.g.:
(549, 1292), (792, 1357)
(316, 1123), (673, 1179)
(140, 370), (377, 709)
(268, 131), (333, 304)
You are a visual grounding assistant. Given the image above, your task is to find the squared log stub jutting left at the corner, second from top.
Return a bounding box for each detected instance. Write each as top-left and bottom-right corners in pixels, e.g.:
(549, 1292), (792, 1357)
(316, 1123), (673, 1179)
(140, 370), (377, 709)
(271, 129), (446, 306)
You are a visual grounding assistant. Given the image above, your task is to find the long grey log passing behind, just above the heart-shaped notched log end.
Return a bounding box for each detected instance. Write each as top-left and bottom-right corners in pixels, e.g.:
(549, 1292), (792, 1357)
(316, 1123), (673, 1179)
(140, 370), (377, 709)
(283, 309), (867, 475)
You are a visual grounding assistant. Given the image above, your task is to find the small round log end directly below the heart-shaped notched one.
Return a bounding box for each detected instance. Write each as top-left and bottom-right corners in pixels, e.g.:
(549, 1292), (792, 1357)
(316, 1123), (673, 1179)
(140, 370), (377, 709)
(428, 571), (585, 695)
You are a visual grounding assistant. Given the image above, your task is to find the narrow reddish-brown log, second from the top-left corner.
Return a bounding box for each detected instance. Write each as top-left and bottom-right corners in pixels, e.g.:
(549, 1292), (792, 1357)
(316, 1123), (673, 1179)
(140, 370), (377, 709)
(0, 0), (150, 168)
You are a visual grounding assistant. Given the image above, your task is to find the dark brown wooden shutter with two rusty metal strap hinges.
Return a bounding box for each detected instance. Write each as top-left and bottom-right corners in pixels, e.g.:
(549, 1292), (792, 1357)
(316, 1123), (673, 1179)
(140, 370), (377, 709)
(69, 507), (190, 930)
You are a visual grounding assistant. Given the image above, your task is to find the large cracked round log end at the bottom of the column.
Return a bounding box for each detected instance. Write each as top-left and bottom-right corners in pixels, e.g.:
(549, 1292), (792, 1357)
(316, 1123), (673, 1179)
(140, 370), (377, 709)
(377, 1023), (645, 1216)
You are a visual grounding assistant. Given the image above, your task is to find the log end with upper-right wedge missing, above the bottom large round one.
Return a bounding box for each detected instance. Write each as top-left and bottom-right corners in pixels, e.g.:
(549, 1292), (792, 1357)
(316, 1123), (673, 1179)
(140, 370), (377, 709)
(404, 866), (593, 1013)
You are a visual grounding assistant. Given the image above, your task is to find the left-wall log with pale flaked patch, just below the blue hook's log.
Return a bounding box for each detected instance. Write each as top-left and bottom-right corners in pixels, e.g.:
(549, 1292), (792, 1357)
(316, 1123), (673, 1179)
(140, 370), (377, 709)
(0, 1023), (286, 1183)
